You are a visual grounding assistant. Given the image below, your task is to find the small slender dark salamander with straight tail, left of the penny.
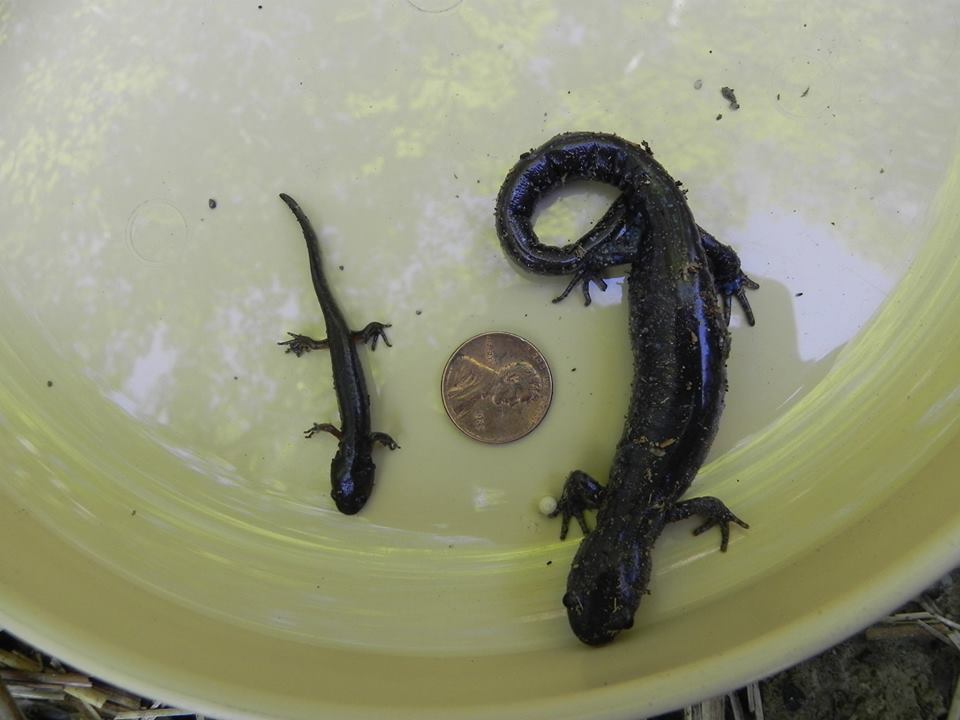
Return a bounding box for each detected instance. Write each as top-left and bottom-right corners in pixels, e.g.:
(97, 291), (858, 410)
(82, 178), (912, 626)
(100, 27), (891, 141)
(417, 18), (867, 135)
(278, 193), (399, 515)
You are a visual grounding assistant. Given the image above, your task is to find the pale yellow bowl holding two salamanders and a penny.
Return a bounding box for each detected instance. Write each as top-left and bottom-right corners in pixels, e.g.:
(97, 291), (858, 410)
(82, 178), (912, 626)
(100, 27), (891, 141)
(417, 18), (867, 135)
(0, 0), (960, 719)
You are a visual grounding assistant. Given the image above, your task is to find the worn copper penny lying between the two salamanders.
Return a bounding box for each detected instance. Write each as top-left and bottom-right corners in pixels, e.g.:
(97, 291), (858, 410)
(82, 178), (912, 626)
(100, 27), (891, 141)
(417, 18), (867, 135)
(440, 332), (553, 443)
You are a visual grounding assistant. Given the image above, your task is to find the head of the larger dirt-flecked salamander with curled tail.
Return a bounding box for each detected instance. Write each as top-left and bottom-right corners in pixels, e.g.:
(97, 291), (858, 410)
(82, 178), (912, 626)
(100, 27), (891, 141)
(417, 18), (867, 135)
(563, 534), (650, 645)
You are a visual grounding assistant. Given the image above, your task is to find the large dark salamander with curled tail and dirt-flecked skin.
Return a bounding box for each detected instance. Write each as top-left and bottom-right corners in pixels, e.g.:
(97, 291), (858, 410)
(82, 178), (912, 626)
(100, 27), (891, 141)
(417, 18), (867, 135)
(496, 132), (758, 645)
